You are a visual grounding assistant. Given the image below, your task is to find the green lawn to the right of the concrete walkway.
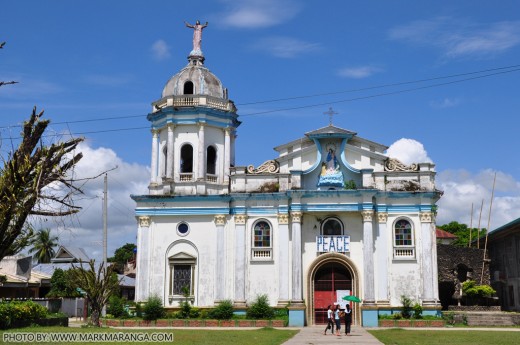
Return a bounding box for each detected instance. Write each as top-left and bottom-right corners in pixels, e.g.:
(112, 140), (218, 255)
(368, 328), (520, 345)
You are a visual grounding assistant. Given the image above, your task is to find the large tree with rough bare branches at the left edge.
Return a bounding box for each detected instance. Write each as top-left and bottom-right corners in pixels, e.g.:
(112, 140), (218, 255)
(0, 107), (83, 260)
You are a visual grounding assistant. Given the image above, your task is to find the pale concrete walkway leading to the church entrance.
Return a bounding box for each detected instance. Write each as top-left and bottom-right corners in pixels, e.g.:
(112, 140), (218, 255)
(283, 325), (383, 345)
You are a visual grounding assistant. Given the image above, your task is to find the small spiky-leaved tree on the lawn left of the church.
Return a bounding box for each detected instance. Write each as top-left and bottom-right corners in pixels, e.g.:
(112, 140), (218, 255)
(69, 260), (119, 327)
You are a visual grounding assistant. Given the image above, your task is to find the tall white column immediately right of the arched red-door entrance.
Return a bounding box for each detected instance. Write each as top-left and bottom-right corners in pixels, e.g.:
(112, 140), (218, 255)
(361, 210), (375, 304)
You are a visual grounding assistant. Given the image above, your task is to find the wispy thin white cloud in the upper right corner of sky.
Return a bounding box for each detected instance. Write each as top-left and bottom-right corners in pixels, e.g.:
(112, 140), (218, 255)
(389, 17), (520, 58)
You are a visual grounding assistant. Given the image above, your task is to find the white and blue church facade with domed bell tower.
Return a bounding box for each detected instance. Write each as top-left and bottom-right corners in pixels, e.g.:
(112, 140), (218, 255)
(132, 24), (441, 326)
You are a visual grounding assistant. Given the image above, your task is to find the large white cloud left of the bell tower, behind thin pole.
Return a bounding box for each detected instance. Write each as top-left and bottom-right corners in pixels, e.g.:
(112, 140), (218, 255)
(29, 143), (150, 259)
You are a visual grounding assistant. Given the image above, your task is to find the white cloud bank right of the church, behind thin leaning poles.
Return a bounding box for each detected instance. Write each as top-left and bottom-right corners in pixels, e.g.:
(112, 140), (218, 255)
(436, 169), (520, 229)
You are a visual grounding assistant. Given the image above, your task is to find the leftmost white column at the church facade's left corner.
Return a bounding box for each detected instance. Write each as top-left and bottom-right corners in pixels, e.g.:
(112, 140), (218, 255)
(135, 217), (150, 302)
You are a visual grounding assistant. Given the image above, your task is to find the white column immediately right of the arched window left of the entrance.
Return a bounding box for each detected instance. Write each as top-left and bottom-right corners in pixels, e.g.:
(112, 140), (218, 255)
(278, 214), (289, 306)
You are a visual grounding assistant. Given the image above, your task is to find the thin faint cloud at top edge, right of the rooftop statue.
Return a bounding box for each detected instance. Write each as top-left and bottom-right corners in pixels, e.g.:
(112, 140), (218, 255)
(221, 0), (300, 28)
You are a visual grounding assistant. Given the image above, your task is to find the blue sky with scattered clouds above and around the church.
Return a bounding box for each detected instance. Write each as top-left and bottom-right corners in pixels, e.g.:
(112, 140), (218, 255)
(0, 0), (520, 255)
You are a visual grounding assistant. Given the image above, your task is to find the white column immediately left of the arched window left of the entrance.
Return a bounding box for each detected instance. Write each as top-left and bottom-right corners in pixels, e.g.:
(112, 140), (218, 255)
(235, 214), (247, 307)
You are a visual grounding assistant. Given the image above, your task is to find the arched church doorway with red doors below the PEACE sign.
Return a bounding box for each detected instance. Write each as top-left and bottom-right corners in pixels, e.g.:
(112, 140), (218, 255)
(307, 253), (360, 324)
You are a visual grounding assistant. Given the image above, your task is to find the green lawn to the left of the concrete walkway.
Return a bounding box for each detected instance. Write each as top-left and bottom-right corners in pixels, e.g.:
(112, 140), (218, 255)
(0, 327), (298, 345)
